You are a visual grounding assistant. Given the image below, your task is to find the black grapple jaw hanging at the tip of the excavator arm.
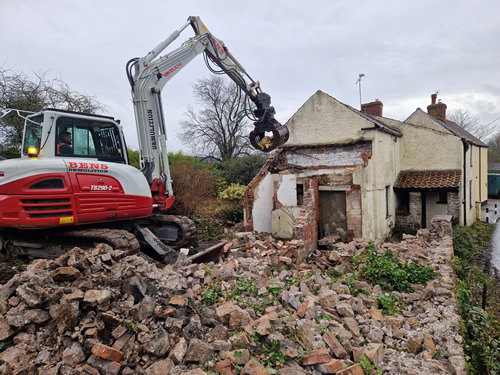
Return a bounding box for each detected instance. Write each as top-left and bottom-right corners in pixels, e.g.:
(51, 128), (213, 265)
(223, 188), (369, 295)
(250, 93), (290, 152)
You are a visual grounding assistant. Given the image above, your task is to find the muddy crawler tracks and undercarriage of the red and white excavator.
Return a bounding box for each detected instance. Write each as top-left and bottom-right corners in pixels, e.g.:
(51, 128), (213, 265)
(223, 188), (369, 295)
(0, 215), (196, 264)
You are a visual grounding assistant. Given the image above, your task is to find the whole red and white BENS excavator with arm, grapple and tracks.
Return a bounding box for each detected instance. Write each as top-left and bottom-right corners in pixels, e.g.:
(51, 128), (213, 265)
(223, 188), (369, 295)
(0, 17), (289, 263)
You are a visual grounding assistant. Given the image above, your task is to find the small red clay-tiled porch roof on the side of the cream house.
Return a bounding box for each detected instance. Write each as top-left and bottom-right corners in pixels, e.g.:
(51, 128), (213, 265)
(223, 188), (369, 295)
(394, 170), (462, 190)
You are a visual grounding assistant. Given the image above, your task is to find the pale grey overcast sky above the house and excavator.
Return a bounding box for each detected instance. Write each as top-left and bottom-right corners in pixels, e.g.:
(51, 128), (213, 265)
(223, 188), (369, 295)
(0, 0), (500, 153)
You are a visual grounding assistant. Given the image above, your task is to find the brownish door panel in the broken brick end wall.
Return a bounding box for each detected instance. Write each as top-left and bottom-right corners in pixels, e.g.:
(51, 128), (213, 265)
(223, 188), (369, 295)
(319, 191), (347, 241)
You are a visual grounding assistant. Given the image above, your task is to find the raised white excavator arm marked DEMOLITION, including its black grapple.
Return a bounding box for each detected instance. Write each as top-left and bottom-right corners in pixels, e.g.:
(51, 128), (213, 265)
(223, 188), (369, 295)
(127, 17), (288, 209)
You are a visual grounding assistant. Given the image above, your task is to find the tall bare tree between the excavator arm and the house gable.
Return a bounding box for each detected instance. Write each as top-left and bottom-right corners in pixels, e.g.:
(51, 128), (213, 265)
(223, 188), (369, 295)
(179, 76), (251, 161)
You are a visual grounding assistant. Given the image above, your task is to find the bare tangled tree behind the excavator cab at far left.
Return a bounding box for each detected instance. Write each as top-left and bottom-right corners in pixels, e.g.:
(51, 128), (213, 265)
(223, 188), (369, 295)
(0, 67), (105, 150)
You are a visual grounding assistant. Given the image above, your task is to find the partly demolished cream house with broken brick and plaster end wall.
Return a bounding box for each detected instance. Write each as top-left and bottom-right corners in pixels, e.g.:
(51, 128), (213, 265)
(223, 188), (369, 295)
(245, 91), (488, 253)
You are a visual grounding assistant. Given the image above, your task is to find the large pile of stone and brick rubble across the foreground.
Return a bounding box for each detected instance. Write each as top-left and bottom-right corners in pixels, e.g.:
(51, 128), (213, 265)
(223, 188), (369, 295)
(0, 220), (465, 375)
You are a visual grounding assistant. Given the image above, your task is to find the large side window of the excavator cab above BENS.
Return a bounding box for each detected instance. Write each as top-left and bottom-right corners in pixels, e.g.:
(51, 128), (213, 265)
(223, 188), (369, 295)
(56, 117), (125, 163)
